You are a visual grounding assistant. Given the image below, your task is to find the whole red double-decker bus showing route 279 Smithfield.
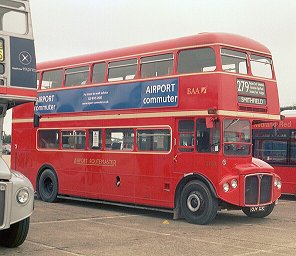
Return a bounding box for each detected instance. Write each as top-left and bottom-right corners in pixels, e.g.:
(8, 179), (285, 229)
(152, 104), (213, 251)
(11, 33), (281, 224)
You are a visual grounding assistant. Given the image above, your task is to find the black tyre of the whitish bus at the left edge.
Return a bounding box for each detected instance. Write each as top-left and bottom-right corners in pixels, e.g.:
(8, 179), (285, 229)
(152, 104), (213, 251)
(0, 217), (30, 248)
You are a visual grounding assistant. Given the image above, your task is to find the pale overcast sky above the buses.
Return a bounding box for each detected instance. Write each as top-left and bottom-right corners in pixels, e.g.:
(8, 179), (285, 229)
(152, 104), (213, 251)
(6, 0), (296, 130)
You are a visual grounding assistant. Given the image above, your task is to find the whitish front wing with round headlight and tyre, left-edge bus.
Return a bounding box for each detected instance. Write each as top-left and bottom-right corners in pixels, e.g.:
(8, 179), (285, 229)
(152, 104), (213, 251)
(0, 153), (34, 247)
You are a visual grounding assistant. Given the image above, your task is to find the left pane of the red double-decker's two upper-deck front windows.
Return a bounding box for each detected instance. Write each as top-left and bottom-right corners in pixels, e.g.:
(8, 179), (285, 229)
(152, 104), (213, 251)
(221, 48), (248, 74)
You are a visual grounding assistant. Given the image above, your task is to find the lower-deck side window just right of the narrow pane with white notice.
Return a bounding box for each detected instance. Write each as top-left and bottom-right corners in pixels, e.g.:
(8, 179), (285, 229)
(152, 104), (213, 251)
(105, 128), (134, 151)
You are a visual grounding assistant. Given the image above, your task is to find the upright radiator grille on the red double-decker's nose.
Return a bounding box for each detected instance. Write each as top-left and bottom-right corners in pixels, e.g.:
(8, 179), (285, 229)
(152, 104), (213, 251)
(245, 174), (272, 205)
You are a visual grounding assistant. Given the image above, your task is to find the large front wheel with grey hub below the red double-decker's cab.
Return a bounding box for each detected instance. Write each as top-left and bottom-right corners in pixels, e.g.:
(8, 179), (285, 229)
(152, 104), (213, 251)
(181, 180), (218, 225)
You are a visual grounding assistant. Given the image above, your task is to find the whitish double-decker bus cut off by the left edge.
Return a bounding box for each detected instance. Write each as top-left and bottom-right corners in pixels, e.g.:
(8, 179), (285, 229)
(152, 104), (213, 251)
(0, 0), (36, 247)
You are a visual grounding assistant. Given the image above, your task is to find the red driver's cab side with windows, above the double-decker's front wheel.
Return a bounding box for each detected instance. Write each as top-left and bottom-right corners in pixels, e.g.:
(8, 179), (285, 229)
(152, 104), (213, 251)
(174, 117), (220, 175)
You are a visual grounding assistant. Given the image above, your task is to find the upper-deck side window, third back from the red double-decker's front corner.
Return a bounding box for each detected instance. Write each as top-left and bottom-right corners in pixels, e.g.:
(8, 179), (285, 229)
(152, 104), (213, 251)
(108, 59), (138, 82)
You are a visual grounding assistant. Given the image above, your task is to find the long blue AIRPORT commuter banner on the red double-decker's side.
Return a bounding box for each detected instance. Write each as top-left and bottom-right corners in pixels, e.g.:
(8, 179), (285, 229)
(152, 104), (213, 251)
(35, 79), (178, 114)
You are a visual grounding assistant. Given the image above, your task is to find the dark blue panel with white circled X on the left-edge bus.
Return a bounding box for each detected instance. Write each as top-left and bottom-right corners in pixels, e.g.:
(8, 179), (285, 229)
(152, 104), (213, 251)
(9, 37), (37, 89)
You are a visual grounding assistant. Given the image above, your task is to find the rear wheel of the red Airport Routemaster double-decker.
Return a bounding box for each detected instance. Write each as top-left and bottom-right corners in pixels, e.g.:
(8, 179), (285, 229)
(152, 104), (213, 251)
(38, 169), (58, 203)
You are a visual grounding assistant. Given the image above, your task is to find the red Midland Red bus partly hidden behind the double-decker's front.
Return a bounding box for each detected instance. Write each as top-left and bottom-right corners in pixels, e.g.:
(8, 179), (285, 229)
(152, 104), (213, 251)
(253, 110), (296, 195)
